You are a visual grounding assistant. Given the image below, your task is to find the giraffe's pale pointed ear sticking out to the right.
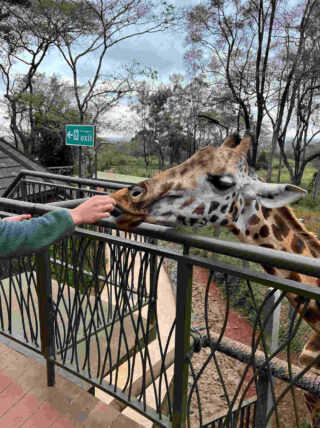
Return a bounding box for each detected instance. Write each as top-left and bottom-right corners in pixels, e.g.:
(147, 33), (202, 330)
(256, 182), (308, 208)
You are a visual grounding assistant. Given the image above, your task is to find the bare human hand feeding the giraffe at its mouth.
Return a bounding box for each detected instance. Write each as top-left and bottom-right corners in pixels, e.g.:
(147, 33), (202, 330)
(70, 195), (116, 225)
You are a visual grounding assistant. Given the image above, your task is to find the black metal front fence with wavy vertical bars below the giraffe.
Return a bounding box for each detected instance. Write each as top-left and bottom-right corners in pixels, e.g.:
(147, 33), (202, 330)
(0, 171), (320, 428)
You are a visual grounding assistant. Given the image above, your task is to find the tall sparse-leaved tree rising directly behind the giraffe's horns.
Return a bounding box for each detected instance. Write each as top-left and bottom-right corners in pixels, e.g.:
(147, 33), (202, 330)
(186, 0), (281, 166)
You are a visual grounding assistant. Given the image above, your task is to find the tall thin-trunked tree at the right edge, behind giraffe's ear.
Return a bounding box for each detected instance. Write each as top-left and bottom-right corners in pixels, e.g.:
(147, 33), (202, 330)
(266, 0), (320, 185)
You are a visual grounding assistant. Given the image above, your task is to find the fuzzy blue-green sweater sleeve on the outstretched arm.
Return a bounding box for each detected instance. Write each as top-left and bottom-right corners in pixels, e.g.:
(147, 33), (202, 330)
(0, 209), (75, 258)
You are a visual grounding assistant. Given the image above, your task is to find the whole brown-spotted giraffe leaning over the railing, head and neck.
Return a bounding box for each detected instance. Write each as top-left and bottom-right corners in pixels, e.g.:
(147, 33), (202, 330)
(111, 135), (320, 421)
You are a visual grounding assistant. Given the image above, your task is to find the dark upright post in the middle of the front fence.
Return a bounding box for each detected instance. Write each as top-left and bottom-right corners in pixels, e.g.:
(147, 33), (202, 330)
(172, 247), (192, 428)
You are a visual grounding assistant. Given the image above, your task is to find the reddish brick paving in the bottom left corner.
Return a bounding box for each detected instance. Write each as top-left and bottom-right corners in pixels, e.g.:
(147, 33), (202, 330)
(0, 343), (141, 428)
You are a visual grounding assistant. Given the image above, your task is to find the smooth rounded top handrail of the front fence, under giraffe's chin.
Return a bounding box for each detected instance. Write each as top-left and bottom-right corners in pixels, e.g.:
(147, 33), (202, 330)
(0, 198), (320, 277)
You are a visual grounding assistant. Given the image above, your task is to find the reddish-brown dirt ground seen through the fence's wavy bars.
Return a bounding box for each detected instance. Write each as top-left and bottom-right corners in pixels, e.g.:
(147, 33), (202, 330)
(189, 267), (308, 428)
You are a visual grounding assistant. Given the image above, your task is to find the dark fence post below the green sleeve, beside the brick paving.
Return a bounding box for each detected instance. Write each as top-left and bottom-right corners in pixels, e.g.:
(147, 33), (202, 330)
(36, 248), (55, 386)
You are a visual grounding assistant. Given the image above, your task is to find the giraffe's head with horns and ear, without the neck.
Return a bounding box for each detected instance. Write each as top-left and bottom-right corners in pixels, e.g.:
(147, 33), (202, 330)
(112, 136), (306, 230)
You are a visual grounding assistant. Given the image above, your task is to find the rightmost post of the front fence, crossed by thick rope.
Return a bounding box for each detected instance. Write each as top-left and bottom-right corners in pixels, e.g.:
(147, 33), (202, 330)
(255, 288), (281, 428)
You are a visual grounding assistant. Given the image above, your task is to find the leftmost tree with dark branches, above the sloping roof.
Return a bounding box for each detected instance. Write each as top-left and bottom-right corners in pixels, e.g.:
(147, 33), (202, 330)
(0, 1), (64, 154)
